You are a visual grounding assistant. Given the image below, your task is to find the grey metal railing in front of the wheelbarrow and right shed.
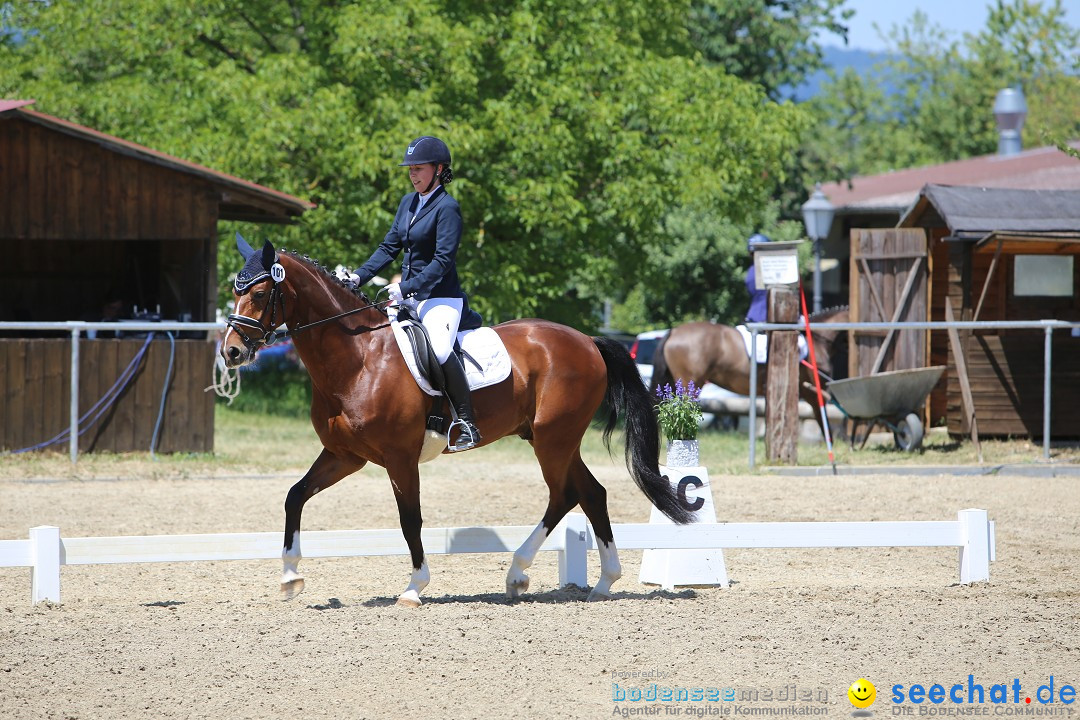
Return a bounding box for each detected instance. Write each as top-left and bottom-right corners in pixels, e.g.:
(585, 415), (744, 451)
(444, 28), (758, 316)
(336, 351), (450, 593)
(746, 320), (1080, 468)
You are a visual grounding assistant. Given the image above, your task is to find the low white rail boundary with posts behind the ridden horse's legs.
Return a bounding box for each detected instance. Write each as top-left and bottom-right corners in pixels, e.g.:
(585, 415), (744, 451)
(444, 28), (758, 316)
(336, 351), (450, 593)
(0, 510), (995, 602)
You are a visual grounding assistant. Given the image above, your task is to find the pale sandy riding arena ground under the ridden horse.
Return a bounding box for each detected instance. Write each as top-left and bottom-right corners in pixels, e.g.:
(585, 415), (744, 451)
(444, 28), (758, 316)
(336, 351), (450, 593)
(0, 440), (1080, 720)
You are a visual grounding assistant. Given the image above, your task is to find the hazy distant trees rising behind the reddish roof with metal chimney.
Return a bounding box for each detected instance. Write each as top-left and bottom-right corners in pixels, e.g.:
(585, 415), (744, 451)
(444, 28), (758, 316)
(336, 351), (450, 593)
(805, 0), (1080, 180)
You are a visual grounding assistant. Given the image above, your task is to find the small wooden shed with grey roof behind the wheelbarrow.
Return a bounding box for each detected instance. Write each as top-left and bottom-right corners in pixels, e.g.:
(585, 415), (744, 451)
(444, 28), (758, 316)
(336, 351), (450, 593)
(850, 185), (1080, 438)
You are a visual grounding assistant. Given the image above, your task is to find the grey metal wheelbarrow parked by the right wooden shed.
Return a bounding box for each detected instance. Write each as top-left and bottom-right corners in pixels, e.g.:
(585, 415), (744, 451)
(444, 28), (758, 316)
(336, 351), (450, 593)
(826, 365), (945, 452)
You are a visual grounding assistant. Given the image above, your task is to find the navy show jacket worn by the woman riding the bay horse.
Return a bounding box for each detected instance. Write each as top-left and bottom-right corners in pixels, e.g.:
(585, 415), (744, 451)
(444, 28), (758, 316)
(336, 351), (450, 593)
(356, 186), (483, 330)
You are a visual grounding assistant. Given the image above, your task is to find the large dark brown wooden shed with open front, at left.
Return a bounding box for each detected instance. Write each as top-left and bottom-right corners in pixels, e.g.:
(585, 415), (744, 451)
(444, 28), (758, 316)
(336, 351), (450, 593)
(0, 100), (313, 452)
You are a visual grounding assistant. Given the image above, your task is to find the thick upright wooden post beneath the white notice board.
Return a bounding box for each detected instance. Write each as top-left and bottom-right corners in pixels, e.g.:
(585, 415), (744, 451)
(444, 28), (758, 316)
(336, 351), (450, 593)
(765, 285), (799, 465)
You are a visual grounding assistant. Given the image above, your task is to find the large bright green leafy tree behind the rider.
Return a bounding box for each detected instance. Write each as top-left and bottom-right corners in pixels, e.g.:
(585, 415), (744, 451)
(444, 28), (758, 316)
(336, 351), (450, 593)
(0, 0), (806, 328)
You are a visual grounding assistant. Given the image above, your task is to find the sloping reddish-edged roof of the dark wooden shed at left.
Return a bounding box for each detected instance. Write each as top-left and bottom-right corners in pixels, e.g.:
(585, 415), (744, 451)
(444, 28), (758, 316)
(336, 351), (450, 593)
(0, 99), (315, 222)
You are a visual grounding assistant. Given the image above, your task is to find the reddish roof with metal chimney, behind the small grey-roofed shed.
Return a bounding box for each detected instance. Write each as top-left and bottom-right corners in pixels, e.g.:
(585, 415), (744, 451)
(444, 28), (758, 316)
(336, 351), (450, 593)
(821, 140), (1080, 215)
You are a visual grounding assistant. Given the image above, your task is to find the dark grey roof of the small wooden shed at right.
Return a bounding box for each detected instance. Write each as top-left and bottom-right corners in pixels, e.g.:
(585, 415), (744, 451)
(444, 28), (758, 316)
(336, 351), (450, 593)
(897, 184), (1080, 236)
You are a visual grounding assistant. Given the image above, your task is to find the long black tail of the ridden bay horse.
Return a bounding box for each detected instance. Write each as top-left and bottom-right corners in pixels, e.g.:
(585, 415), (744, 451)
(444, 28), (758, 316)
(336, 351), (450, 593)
(593, 338), (692, 525)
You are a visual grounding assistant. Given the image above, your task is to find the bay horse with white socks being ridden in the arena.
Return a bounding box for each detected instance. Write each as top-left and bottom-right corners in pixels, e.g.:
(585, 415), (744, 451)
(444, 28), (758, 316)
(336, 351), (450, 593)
(220, 239), (691, 607)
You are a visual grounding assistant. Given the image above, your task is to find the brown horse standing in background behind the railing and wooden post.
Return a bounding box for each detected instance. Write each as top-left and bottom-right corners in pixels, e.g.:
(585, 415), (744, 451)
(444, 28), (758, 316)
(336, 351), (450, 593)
(651, 307), (848, 432)
